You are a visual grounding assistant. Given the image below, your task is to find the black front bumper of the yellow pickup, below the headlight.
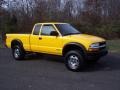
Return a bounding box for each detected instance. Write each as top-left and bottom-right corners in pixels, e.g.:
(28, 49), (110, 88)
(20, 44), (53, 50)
(87, 49), (108, 60)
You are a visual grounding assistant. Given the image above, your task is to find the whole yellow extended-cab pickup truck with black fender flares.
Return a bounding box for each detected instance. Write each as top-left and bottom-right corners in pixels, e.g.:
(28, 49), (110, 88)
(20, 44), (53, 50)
(6, 23), (108, 71)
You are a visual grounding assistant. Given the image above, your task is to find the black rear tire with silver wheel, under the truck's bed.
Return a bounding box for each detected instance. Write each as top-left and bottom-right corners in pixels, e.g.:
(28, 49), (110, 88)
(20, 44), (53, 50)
(12, 45), (25, 60)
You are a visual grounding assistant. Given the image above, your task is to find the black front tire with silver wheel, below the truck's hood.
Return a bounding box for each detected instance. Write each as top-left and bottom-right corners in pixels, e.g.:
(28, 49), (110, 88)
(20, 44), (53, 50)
(65, 50), (84, 72)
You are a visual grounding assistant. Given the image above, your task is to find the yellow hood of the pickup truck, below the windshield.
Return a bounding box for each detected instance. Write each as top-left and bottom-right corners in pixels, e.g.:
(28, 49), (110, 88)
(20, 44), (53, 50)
(64, 34), (105, 43)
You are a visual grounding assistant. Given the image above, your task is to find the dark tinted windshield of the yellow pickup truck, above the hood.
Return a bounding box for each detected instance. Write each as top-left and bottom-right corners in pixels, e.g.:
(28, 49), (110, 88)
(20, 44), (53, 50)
(55, 24), (80, 36)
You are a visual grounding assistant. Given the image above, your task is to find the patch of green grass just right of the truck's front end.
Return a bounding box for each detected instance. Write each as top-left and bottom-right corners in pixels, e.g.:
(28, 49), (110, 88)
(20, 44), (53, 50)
(107, 39), (120, 53)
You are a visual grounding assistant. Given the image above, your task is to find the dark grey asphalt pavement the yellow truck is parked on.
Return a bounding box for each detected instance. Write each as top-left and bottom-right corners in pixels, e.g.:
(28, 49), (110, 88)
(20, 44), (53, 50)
(0, 49), (120, 90)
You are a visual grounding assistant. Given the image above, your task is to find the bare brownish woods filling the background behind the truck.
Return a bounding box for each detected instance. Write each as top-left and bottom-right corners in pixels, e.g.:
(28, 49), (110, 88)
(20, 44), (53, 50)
(0, 0), (120, 39)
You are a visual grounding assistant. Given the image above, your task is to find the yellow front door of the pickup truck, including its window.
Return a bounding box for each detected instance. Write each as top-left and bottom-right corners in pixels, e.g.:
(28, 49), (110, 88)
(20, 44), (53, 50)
(38, 24), (62, 55)
